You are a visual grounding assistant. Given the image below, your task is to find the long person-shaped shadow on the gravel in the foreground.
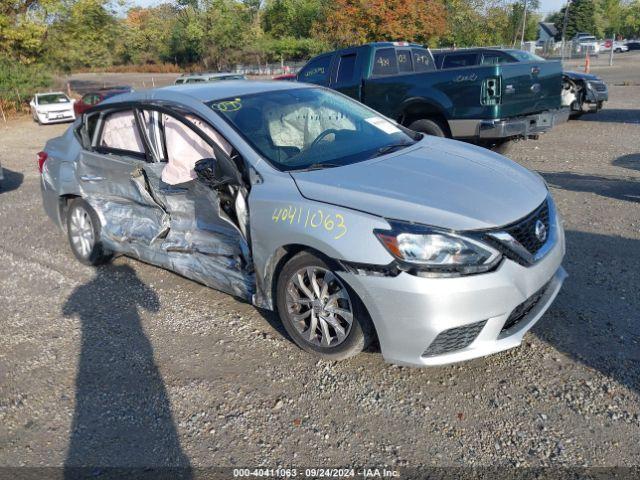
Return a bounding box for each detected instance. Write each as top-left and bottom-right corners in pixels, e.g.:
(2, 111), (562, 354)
(63, 265), (191, 479)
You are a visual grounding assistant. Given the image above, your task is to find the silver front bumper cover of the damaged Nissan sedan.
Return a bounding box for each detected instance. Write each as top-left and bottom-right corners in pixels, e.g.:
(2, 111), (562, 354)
(342, 216), (567, 366)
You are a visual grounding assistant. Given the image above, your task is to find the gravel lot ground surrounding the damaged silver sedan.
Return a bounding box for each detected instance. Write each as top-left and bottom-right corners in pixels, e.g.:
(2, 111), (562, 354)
(0, 62), (640, 467)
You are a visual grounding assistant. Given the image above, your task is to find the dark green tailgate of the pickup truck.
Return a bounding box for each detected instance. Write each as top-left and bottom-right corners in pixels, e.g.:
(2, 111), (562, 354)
(500, 61), (562, 118)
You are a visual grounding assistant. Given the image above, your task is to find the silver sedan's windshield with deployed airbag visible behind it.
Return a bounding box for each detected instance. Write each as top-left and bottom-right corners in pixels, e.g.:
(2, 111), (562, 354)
(209, 88), (420, 171)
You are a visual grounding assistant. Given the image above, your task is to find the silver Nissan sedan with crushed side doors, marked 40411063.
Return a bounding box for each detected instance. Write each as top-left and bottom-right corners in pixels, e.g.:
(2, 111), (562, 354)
(38, 81), (566, 365)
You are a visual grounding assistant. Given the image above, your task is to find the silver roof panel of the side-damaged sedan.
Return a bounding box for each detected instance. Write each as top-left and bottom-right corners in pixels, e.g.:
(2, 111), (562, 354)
(102, 80), (318, 105)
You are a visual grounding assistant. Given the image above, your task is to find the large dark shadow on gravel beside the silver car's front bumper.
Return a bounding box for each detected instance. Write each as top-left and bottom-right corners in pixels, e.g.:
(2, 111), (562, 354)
(532, 231), (640, 392)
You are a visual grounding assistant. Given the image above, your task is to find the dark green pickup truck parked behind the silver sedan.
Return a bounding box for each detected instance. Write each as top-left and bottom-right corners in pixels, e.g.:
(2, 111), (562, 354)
(297, 42), (569, 149)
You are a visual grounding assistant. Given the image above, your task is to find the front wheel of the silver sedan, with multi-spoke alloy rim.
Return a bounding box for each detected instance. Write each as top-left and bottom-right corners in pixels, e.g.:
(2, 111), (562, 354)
(276, 252), (374, 360)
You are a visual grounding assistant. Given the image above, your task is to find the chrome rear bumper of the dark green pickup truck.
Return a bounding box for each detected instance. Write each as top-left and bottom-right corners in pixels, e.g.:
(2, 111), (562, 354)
(478, 108), (569, 140)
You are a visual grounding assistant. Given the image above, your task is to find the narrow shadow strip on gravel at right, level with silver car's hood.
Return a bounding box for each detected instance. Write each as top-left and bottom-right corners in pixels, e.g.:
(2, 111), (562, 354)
(541, 172), (640, 203)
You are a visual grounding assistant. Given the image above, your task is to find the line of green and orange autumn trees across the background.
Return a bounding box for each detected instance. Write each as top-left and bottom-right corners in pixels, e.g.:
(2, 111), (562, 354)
(0, 0), (640, 73)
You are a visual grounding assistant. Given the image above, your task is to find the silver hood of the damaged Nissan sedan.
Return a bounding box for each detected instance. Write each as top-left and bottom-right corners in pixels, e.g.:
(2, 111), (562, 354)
(291, 137), (548, 230)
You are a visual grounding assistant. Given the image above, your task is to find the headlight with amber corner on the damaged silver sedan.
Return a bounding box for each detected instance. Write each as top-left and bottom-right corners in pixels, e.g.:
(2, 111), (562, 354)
(374, 223), (502, 275)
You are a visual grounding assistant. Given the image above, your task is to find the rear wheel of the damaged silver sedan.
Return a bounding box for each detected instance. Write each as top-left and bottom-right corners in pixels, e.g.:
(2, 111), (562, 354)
(67, 198), (111, 265)
